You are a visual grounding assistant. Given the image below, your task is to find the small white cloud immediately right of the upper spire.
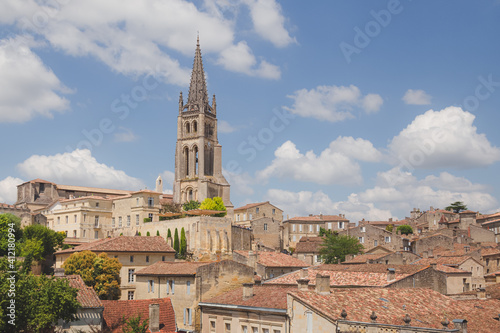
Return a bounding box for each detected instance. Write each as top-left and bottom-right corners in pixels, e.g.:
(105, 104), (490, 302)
(217, 41), (281, 80)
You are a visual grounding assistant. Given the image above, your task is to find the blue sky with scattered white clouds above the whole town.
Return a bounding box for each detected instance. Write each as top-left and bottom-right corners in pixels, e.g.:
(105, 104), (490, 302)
(0, 0), (500, 221)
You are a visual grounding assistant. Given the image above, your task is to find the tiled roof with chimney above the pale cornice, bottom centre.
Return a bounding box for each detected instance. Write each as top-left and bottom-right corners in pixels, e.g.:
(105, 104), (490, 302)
(203, 284), (297, 310)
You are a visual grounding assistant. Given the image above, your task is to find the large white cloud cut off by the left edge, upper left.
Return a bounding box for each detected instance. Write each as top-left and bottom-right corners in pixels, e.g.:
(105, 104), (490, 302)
(0, 36), (70, 123)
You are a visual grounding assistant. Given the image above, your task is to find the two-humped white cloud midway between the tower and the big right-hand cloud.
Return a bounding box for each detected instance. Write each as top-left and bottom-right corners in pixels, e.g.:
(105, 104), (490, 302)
(257, 137), (381, 185)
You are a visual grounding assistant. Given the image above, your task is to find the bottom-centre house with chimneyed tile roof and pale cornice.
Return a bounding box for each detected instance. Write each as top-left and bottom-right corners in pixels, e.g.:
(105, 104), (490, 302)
(199, 283), (297, 333)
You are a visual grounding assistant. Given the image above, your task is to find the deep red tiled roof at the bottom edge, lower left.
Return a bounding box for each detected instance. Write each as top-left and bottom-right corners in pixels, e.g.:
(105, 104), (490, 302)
(102, 298), (177, 333)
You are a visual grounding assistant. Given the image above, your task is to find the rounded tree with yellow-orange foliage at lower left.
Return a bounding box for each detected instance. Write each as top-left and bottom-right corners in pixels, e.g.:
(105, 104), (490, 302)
(63, 251), (122, 300)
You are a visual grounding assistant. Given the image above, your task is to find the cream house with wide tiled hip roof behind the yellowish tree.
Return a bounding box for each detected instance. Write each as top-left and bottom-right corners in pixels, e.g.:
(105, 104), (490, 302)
(55, 236), (175, 300)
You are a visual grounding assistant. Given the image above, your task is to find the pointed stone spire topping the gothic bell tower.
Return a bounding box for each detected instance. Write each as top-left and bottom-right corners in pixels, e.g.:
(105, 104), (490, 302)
(187, 36), (208, 111)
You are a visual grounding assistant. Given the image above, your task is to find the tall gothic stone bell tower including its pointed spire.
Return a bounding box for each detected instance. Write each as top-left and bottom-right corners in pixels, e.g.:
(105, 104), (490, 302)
(174, 38), (234, 213)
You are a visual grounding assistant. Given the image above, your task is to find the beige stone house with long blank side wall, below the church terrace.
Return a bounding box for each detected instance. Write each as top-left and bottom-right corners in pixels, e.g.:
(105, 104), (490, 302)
(135, 260), (254, 331)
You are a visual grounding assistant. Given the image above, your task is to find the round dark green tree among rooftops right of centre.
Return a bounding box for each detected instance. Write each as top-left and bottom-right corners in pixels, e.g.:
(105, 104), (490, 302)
(319, 234), (363, 264)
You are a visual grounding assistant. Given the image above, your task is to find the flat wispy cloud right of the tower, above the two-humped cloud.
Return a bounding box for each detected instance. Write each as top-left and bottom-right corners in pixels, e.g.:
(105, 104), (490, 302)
(284, 85), (383, 122)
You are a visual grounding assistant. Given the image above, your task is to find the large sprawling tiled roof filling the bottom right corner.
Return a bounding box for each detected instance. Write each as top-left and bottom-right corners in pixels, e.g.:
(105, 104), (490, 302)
(289, 288), (500, 333)
